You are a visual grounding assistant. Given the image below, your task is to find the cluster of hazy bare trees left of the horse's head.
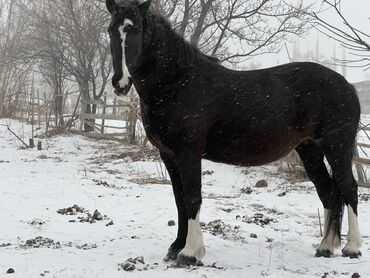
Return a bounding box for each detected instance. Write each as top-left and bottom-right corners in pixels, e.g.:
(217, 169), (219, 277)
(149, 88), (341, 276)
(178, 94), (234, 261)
(0, 0), (111, 129)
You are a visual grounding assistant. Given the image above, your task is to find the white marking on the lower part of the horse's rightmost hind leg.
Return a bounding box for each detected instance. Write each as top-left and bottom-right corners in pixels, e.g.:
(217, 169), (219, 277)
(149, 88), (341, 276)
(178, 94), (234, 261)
(343, 205), (362, 253)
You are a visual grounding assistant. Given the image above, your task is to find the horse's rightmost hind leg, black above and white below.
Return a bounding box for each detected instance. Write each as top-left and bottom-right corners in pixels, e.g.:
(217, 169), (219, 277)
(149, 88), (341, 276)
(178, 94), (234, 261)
(326, 146), (362, 258)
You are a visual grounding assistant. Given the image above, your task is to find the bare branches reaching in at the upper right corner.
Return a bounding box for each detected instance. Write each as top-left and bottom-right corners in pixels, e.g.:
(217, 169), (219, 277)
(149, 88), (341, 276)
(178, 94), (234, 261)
(311, 0), (370, 70)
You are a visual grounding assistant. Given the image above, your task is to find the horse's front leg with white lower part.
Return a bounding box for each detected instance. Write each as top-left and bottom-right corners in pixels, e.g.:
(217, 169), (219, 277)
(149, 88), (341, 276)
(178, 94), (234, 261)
(175, 147), (205, 265)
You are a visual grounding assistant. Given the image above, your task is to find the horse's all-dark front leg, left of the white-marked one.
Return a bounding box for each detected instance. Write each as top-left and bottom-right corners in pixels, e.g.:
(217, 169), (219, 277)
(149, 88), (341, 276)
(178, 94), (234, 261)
(161, 152), (188, 262)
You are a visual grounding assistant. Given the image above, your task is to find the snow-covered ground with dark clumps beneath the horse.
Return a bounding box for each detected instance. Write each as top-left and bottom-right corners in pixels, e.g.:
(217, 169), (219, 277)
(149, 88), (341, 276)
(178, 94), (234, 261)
(0, 120), (370, 278)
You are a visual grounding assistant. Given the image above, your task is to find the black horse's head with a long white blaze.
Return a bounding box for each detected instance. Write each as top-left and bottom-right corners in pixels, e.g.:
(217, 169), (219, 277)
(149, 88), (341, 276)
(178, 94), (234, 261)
(106, 0), (151, 95)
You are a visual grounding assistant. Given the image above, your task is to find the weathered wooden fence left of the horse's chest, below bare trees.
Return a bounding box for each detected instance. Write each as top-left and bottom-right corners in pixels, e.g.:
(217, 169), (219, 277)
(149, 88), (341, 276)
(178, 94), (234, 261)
(9, 87), (143, 143)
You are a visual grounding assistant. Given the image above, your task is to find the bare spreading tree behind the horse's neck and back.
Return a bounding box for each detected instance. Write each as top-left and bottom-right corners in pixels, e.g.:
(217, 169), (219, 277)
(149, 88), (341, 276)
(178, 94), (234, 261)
(154, 0), (310, 64)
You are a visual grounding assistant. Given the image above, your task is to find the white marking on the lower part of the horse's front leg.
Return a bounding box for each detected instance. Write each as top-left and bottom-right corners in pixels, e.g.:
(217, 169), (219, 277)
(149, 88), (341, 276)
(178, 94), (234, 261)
(179, 212), (206, 262)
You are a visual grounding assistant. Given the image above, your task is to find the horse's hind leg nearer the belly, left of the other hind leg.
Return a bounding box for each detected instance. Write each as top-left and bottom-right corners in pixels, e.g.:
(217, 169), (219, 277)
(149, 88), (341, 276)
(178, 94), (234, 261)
(296, 140), (343, 257)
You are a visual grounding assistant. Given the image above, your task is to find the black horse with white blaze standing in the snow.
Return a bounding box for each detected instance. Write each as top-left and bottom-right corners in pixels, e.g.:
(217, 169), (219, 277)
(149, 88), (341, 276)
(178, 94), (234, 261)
(106, 0), (361, 264)
